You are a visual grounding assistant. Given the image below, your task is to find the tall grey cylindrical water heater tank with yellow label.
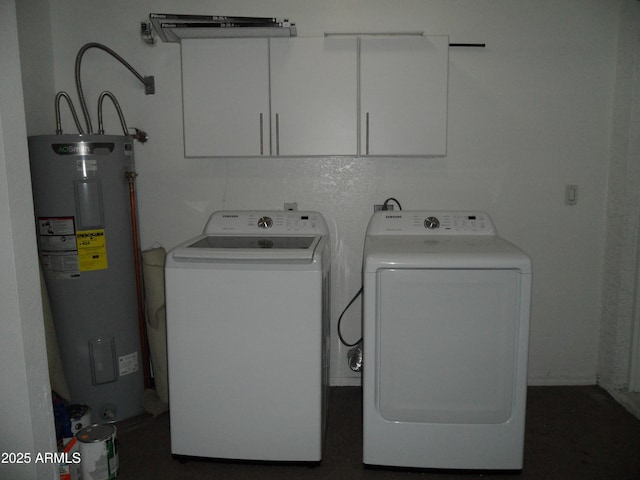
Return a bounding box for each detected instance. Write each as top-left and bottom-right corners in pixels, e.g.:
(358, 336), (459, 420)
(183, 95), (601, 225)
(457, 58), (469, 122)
(29, 134), (144, 423)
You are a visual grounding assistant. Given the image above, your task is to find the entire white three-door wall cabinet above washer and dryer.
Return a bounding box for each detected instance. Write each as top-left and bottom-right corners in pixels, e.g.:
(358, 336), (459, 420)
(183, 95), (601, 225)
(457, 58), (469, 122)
(181, 36), (449, 157)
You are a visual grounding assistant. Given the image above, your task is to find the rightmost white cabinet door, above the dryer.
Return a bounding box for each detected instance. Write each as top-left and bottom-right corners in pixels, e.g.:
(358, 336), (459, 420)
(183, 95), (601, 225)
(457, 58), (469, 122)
(360, 36), (449, 156)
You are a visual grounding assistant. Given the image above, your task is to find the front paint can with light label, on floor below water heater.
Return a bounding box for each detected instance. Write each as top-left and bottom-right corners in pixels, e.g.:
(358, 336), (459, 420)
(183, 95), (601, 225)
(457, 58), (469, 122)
(76, 424), (120, 480)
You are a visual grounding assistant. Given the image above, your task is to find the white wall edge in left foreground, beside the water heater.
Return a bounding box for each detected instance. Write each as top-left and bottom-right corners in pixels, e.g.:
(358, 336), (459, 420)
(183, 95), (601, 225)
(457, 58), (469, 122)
(0, 0), (56, 480)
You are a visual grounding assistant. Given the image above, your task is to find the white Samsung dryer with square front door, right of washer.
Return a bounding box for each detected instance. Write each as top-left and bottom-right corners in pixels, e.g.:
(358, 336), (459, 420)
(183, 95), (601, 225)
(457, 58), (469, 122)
(363, 211), (532, 470)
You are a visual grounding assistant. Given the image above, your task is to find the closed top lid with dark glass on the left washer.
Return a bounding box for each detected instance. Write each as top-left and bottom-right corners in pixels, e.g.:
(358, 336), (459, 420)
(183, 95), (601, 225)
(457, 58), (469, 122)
(172, 234), (322, 263)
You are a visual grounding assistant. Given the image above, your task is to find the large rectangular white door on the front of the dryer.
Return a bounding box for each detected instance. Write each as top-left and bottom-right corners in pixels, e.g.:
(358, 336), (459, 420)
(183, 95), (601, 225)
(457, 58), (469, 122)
(376, 269), (521, 424)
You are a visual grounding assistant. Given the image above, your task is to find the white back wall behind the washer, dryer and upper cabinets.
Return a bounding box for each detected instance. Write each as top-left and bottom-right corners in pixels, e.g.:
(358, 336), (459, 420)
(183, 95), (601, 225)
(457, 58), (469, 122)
(40, 0), (622, 384)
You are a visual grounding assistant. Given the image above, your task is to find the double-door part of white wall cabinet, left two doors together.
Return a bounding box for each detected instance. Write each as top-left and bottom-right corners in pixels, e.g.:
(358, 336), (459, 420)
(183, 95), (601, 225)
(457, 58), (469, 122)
(182, 38), (358, 157)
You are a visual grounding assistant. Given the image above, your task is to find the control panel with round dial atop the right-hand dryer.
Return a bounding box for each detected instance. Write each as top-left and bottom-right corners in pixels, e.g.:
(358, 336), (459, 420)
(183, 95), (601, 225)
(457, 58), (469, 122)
(367, 210), (497, 235)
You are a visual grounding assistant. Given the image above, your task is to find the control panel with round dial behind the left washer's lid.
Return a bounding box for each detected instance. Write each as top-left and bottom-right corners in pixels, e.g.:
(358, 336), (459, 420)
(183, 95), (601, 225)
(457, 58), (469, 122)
(204, 210), (329, 235)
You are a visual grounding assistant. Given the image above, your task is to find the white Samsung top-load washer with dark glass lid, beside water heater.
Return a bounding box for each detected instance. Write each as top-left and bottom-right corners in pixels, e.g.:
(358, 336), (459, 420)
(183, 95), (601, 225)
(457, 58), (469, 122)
(165, 211), (330, 462)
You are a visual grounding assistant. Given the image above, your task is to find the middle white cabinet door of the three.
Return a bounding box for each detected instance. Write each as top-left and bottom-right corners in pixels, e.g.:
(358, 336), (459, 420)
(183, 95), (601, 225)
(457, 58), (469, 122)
(270, 37), (358, 156)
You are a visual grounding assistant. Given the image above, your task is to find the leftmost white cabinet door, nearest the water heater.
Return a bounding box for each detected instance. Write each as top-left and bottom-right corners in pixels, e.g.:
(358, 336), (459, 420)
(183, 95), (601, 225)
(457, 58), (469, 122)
(181, 38), (270, 157)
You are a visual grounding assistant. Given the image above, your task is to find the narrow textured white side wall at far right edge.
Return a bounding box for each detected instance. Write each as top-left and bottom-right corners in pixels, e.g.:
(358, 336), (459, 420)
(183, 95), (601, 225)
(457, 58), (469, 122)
(599, 1), (640, 398)
